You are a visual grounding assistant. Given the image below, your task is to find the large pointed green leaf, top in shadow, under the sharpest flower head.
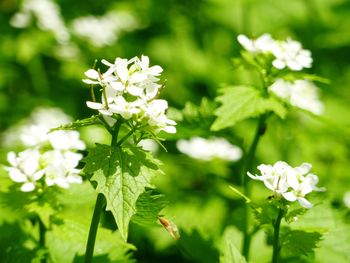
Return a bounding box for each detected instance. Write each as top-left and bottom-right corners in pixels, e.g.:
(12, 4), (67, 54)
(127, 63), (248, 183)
(83, 144), (160, 241)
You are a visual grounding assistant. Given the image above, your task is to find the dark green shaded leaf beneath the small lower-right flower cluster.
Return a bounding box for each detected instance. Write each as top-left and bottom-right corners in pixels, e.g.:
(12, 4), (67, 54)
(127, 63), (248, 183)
(280, 228), (322, 257)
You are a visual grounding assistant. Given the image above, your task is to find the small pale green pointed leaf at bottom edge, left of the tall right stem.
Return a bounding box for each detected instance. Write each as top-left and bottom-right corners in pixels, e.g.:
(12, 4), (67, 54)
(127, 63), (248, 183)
(220, 228), (246, 263)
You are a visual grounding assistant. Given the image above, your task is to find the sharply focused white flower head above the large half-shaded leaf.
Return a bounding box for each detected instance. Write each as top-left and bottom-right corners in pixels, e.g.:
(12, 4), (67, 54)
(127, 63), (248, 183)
(83, 56), (176, 133)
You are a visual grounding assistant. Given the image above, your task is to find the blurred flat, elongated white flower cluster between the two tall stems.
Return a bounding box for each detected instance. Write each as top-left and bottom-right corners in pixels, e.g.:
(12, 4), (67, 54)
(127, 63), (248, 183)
(176, 137), (242, 161)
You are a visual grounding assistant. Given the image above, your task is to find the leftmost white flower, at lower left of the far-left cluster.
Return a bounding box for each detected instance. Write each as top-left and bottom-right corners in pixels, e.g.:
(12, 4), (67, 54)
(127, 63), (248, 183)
(5, 149), (44, 192)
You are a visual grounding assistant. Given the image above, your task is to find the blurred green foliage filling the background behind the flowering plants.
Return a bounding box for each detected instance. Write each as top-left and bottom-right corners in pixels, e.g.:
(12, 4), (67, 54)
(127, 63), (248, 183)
(0, 0), (350, 263)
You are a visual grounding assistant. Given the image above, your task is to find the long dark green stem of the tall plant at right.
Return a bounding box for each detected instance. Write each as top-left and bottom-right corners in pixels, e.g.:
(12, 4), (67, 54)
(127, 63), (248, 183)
(241, 115), (267, 260)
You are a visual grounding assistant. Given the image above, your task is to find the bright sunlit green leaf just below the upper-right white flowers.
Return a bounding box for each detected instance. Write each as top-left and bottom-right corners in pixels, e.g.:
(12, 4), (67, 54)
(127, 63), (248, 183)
(211, 86), (286, 131)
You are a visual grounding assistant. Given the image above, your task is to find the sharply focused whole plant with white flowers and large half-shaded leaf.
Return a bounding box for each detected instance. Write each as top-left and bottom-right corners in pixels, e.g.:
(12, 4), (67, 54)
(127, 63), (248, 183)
(80, 55), (176, 262)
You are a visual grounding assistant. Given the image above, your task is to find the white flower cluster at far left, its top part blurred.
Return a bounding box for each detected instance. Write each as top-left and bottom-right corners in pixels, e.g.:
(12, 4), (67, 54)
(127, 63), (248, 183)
(5, 109), (85, 192)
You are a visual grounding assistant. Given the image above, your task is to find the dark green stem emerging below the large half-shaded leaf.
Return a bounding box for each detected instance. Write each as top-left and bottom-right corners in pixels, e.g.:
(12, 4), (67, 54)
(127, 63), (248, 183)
(84, 193), (104, 263)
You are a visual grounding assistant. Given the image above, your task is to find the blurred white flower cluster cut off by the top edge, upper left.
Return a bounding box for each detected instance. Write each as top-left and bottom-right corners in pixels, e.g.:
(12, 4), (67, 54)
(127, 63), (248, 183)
(10, 0), (70, 43)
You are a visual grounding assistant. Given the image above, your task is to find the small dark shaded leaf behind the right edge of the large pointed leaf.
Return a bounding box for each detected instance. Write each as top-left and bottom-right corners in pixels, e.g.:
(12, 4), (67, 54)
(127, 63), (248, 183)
(131, 191), (167, 226)
